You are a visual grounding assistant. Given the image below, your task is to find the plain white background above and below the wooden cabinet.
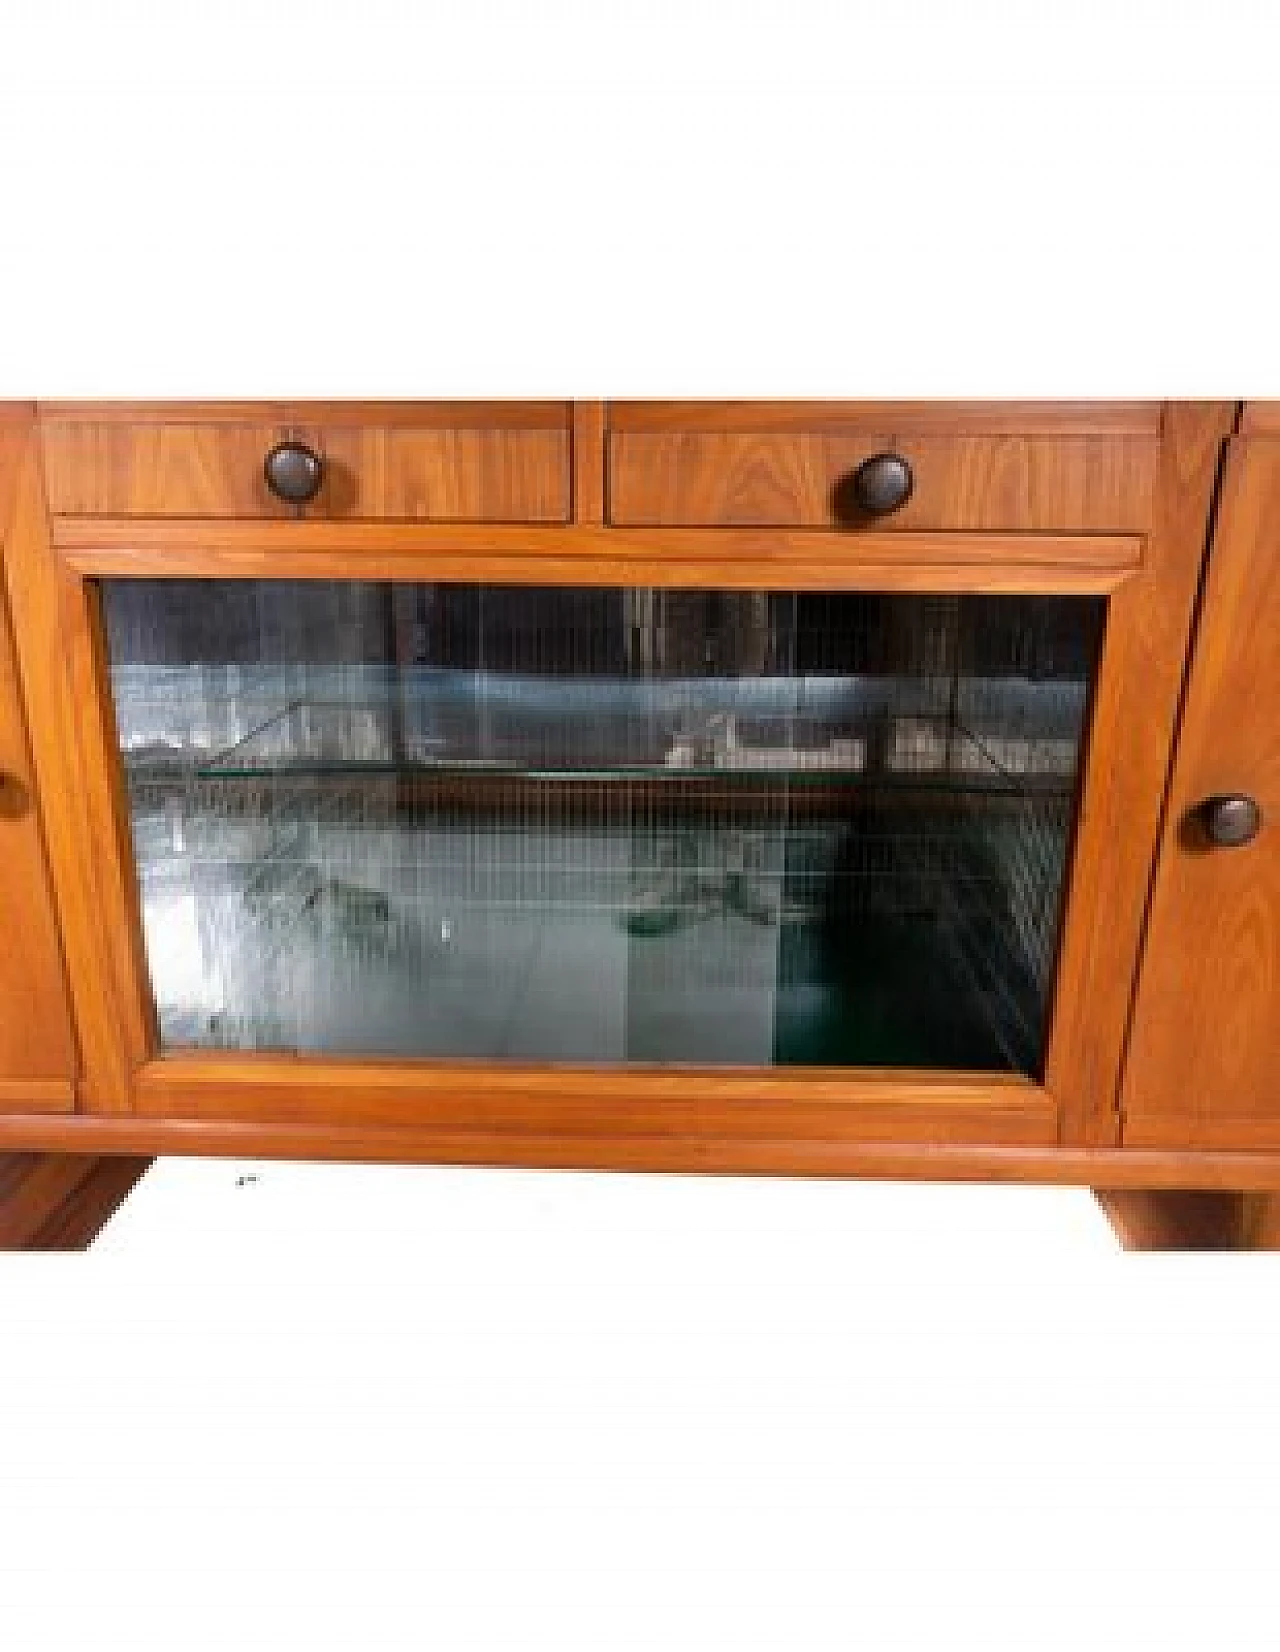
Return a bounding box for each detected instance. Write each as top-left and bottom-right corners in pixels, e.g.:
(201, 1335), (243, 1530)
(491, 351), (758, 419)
(0, 0), (1280, 1652)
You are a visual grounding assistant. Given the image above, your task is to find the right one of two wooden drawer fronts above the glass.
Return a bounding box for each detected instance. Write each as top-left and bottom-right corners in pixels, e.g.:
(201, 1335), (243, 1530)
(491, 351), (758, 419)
(609, 430), (1158, 534)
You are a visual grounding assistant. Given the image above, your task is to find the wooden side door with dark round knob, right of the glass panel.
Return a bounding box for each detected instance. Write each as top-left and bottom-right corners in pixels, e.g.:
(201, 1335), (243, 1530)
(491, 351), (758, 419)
(1123, 438), (1280, 1148)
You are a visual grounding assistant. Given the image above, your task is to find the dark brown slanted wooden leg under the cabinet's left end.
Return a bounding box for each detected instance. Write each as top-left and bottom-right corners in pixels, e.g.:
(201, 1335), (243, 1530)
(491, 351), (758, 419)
(0, 1153), (152, 1251)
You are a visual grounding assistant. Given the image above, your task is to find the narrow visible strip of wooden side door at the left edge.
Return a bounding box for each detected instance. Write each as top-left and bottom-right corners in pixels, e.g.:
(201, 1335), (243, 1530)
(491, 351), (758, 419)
(0, 585), (76, 1113)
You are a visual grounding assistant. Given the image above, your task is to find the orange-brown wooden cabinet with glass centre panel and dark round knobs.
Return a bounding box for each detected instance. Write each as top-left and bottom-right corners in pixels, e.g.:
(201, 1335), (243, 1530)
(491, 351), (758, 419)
(0, 401), (1280, 1247)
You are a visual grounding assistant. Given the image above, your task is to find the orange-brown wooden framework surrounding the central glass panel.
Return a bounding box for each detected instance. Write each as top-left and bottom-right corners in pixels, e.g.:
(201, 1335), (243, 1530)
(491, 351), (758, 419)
(8, 403), (1234, 1171)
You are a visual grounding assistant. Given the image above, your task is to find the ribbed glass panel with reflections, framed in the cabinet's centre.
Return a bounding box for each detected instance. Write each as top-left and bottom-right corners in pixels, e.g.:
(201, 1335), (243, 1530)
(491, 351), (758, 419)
(102, 580), (1102, 1072)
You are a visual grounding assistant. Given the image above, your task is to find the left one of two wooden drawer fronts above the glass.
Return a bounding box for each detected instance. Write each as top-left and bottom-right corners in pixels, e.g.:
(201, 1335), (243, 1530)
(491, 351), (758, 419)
(41, 403), (570, 522)
